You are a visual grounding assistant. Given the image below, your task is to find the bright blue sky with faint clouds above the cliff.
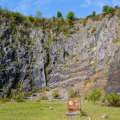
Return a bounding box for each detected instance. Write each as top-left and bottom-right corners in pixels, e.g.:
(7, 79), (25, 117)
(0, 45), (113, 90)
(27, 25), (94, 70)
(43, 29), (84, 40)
(0, 0), (120, 17)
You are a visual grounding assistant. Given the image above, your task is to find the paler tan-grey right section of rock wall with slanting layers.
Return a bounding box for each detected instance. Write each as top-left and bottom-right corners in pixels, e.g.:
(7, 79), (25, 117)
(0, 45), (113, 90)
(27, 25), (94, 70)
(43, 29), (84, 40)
(49, 15), (120, 91)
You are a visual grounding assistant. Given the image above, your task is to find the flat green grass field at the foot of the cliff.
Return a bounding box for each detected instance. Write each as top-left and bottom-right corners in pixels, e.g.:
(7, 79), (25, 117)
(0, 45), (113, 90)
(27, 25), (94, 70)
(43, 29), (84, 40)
(0, 101), (120, 120)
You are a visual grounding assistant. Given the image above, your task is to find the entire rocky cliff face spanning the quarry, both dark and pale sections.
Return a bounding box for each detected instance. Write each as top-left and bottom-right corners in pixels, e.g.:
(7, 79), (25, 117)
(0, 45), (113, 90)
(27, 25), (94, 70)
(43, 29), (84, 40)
(0, 11), (120, 96)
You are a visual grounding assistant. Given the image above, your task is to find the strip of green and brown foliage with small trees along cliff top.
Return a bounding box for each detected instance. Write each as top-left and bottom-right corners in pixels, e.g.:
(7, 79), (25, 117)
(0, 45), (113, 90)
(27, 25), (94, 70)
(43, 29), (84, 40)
(0, 6), (120, 34)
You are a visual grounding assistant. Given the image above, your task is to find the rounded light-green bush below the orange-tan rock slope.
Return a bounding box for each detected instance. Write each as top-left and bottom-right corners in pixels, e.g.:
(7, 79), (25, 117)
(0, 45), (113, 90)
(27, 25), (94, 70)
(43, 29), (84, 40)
(87, 89), (102, 103)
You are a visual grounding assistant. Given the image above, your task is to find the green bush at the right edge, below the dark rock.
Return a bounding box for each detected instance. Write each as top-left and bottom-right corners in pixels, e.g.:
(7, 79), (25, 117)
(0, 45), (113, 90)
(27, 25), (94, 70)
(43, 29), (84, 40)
(106, 93), (120, 106)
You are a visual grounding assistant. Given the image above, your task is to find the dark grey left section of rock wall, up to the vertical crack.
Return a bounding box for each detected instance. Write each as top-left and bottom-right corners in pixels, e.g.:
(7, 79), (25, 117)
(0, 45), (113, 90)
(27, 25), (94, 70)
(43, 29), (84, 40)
(0, 18), (47, 96)
